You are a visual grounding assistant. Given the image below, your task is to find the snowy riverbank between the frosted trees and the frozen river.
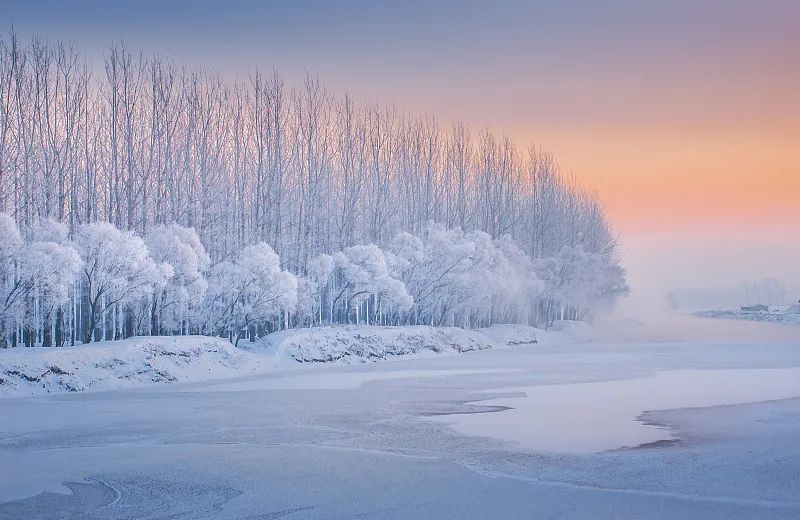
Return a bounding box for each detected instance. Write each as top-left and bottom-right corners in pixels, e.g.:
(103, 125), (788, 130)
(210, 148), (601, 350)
(0, 324), (583, 397)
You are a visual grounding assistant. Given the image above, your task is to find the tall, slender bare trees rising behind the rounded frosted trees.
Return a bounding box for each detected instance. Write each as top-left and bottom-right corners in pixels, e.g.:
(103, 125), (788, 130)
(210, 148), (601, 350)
(0, 33), (615, 264)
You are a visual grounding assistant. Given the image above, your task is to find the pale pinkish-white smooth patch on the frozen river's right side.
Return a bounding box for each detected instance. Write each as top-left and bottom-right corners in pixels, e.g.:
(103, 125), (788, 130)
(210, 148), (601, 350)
(432, 368), (800, 453)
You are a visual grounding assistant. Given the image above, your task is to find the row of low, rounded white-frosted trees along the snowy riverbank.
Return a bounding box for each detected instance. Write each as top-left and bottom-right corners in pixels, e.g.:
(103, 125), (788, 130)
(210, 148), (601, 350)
(0, 214), (626, 346)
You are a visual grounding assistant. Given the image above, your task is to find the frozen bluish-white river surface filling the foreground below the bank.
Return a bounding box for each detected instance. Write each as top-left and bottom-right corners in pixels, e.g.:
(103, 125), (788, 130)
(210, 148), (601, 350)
(0, 318), (800, 520)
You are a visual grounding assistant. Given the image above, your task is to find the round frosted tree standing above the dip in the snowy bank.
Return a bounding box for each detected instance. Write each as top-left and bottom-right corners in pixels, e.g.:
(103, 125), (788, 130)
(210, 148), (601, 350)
(205, 242), (297, 345)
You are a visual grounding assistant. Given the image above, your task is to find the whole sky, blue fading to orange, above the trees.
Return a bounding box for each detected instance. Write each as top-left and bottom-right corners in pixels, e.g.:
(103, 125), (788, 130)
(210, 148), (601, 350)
(0, 0), (800, 308)
